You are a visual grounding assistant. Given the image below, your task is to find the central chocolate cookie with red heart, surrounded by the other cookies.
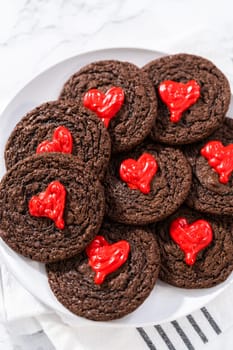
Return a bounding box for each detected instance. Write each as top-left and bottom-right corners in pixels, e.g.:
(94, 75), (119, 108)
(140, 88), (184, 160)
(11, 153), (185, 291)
(104, 144), (191, 225)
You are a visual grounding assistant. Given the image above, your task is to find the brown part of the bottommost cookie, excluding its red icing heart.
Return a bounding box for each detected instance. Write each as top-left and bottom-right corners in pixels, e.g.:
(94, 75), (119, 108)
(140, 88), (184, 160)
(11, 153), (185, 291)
(46, 221), (160, 321)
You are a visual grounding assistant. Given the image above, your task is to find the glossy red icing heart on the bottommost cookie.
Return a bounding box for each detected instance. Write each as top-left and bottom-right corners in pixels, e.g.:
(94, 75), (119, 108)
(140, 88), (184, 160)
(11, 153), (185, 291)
(86, 236), (130, 284)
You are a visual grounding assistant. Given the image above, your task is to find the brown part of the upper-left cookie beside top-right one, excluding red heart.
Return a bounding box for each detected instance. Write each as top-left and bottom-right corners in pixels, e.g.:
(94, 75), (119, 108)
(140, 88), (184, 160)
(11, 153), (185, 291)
(60, 60), (157, 153)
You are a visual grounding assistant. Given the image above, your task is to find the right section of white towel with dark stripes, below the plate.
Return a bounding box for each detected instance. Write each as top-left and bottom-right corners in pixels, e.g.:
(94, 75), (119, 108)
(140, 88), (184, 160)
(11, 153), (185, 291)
(39, 287), (233, 350)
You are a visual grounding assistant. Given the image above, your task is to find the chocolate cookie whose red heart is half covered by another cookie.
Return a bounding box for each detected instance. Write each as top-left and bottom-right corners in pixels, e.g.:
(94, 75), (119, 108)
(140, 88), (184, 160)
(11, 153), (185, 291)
(5, 101), (111, 179)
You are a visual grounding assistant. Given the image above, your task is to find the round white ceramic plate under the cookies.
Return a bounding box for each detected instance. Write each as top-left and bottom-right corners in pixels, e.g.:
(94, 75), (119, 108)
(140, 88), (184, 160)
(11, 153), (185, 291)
(0, 48), (233, 326)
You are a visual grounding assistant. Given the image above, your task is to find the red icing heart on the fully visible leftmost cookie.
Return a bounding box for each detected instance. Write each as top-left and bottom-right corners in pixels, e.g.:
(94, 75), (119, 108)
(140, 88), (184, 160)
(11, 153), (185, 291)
(28, 181), (66, 229)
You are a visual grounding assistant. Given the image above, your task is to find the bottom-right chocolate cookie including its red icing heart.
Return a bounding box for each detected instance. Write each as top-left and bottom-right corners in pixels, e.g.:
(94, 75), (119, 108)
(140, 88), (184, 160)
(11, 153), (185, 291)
(154, 206), (233, 288)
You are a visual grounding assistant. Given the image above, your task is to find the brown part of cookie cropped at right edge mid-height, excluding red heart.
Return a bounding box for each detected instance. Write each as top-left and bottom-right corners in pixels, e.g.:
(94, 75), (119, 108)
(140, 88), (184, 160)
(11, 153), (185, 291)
(184, 118), (233, 216)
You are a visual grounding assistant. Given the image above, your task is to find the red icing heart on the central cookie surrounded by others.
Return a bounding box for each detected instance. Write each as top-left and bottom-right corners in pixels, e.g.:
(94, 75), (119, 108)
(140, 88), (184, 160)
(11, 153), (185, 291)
(120, 153), (158, 194)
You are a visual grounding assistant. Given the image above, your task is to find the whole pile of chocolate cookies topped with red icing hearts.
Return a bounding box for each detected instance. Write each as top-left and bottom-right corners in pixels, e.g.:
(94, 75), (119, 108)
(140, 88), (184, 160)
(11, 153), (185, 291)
(0, 54), (233, 321)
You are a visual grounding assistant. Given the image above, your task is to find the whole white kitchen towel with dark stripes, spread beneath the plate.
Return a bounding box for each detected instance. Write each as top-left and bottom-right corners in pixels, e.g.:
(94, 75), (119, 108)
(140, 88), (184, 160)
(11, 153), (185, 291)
(0, 266), (233, 350)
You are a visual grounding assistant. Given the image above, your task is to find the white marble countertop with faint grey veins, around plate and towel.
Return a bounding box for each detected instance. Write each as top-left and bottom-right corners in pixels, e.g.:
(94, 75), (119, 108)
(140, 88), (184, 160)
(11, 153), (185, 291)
(0, 0), (233, 350)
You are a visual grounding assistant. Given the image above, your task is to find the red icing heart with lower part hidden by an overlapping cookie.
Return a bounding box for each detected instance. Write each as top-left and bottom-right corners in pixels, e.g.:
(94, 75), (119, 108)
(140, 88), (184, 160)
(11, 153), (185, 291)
(36, 126), (73, 153)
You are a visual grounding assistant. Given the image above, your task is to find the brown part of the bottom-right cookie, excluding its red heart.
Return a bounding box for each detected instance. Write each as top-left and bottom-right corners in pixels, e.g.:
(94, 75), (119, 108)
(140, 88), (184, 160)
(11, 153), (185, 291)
(154, 206), (233, 288)
